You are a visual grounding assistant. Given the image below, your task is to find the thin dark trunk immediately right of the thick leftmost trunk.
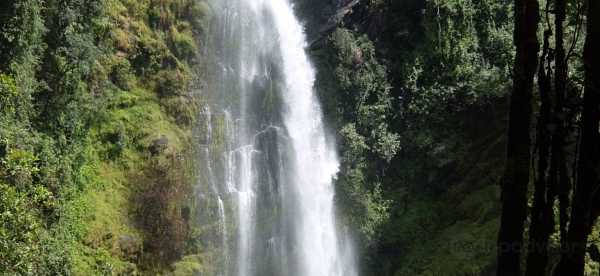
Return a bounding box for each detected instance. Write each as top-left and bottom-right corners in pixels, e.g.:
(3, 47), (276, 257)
(525, 30), (553, 276)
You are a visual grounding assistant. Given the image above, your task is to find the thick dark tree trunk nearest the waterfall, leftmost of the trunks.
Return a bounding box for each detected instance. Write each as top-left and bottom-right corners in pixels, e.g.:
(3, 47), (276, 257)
(496, 0), (539, 276)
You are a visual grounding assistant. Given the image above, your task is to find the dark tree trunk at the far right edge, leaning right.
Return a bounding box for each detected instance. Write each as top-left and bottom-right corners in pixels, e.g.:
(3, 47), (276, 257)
(556, 0), (600, 276)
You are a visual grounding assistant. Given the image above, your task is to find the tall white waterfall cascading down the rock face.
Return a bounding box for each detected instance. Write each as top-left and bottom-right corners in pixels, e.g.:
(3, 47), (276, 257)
(205, 0), (357, 276)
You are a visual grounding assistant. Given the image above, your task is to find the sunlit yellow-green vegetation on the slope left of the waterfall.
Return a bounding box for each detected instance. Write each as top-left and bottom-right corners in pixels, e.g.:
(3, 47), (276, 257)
(0, 0), (210, 275)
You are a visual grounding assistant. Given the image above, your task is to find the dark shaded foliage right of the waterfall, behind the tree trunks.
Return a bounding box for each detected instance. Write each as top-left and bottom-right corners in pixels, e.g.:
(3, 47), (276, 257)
(299, 0), (595, 275)
